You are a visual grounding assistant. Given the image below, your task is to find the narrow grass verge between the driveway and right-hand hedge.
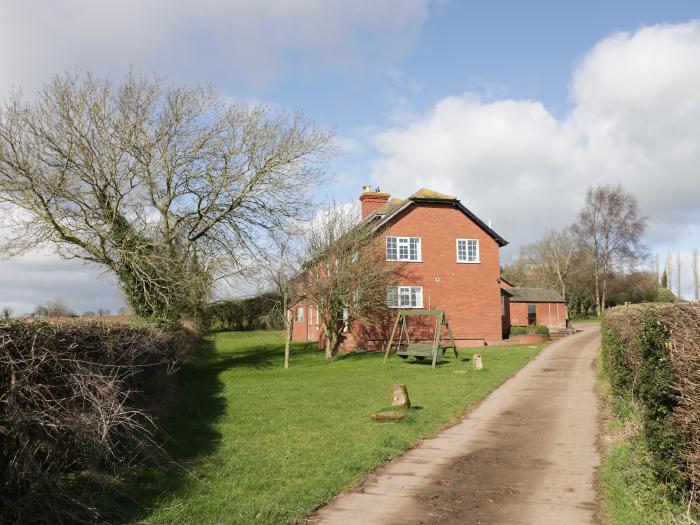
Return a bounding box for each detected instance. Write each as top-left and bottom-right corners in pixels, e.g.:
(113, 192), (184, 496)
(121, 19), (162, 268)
(598, 352), (698, 525)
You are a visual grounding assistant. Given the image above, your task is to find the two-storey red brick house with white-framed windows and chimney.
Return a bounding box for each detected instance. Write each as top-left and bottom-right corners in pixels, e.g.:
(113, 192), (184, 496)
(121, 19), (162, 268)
(291, 187), (511, 351)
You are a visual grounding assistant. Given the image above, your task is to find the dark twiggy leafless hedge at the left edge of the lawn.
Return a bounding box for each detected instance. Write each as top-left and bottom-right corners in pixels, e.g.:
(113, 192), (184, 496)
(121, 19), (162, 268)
(0, 321), (177, 523)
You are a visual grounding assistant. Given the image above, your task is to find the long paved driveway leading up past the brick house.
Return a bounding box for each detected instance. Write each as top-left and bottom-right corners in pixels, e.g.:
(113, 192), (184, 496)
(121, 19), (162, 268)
(310, 325), (600, 525)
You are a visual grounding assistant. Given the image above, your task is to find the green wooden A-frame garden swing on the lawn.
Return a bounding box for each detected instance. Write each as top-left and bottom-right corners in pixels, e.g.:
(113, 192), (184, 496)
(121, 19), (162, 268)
(384, 310), (459, 368)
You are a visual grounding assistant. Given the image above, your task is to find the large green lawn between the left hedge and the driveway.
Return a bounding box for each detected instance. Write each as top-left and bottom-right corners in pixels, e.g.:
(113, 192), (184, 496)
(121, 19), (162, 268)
(113, 332), (541, 524)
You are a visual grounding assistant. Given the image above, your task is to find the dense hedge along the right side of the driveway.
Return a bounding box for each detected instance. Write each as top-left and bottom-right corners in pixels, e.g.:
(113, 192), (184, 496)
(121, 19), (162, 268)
(601, 303), (700, 510)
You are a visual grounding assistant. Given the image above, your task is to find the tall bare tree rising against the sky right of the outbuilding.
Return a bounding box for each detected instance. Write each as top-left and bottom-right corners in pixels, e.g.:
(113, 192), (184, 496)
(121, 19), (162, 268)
(573, 185), (646, 316)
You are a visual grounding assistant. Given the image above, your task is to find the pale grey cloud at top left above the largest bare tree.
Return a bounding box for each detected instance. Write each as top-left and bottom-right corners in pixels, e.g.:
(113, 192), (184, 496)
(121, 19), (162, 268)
(0, 0), (430, 93)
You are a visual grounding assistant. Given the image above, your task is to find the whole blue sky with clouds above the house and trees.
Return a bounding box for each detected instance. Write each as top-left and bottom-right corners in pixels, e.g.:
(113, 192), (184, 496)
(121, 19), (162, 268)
(0, 0), (700, 314)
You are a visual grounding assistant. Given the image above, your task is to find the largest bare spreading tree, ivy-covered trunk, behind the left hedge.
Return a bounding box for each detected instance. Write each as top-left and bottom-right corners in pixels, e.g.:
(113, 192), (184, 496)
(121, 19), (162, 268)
(0, 73), (332, 320)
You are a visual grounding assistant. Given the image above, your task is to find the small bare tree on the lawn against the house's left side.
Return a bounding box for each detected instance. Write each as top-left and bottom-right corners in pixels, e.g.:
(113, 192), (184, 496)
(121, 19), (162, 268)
(299, 205), (400, 359)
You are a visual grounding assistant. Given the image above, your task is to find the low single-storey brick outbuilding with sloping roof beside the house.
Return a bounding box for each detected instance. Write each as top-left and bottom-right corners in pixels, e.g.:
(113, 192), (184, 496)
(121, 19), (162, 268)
(501, 277), (569, 331)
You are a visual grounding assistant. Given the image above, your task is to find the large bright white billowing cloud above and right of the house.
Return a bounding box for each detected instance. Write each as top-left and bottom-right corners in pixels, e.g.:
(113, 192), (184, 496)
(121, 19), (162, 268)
(373, 22), (700, 256)
